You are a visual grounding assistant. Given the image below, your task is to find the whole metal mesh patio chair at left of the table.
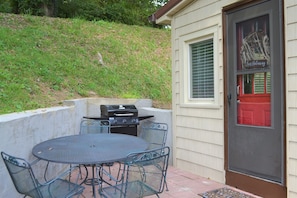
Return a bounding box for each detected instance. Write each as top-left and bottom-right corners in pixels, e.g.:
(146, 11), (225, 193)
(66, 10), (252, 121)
(1, 152), (84, 198)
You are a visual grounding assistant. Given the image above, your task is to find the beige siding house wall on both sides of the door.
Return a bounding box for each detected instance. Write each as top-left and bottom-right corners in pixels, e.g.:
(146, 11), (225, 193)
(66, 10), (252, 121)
(171, 3), (297, 197)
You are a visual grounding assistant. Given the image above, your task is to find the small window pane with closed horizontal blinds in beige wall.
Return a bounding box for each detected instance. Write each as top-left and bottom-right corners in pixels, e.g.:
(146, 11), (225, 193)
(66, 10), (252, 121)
(190, 39), (214, 99)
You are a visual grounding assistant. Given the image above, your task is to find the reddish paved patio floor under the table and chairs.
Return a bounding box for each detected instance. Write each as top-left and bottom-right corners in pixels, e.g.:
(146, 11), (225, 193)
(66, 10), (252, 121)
(76, 166), (260, 198)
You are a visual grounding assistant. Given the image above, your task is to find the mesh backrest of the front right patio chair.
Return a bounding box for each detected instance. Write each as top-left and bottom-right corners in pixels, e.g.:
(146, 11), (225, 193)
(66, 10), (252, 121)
(124, 147), (170, 197)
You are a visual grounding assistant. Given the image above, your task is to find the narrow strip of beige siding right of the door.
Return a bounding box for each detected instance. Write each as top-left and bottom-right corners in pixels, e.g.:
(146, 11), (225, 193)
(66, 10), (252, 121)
(284, 0), (297, 197)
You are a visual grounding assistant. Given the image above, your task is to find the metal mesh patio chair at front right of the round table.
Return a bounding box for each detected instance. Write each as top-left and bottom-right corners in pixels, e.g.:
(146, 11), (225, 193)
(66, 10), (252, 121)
(97, 147), (170, 198)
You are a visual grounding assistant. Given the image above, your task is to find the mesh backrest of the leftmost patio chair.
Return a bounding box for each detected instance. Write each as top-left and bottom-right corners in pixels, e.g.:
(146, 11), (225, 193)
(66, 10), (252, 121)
(1, 152), (42, 198)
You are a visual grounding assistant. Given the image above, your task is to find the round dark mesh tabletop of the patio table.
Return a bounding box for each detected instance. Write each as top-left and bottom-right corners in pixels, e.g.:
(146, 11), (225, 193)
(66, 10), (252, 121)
(32, 134), (148, 164)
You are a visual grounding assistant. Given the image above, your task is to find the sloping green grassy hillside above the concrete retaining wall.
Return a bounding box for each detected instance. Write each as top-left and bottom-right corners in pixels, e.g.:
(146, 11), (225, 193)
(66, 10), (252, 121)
(0, 13), (171, 114)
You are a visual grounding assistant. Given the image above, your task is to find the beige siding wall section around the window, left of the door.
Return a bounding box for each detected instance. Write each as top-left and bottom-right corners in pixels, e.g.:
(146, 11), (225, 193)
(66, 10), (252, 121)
(171, 0), (234, 182)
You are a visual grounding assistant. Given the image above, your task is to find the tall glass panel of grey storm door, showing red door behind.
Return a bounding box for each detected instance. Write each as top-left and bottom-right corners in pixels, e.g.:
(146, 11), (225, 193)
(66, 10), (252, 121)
(236, 14), (271, 126)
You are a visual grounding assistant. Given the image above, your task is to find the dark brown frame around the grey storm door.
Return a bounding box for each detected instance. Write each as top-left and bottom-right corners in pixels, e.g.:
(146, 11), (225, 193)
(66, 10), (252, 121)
(222, 0), (287, 198)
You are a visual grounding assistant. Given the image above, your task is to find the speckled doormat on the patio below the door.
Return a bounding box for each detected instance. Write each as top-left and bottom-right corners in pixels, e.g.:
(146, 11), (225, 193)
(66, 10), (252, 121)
(199, 188), (254, 198)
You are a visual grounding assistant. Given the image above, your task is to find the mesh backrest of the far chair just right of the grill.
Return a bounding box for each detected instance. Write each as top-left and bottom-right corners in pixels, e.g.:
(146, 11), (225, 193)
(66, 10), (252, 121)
(139, 122), (168, 150)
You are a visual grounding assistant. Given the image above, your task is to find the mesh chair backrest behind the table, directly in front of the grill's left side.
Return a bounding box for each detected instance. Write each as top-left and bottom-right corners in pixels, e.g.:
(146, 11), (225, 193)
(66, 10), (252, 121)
(80, 119), (110, 134)
